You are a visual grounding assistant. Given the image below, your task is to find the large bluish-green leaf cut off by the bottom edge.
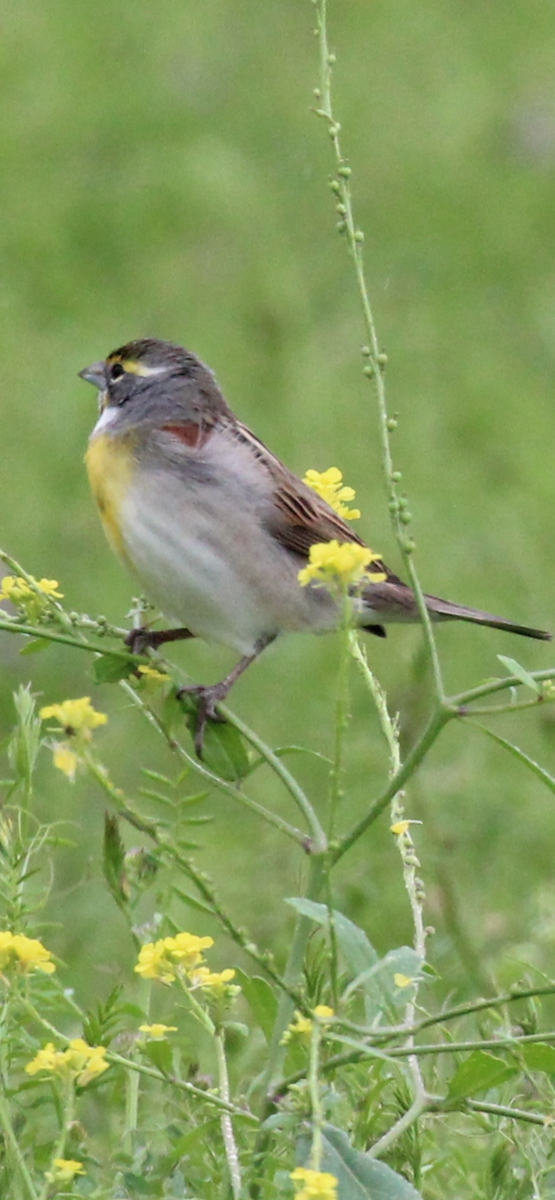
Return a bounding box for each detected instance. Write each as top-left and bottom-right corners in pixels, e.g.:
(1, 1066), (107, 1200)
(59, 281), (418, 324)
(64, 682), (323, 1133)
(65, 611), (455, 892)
(300, 1126), (422, 1200)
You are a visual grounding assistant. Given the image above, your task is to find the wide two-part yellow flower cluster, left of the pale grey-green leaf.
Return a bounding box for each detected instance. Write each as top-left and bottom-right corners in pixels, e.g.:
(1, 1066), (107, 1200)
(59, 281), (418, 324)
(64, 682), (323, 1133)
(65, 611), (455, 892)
(135, 932), (239, 1000)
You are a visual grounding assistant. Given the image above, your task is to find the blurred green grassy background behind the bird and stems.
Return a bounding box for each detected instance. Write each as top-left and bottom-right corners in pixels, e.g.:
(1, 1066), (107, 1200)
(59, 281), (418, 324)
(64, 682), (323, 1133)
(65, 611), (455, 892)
(0, 0), (555, 990)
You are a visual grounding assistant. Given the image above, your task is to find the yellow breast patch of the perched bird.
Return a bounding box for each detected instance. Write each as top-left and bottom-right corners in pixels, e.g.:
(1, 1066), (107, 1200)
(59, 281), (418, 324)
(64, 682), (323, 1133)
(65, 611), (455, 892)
(85, 433), (136, 562)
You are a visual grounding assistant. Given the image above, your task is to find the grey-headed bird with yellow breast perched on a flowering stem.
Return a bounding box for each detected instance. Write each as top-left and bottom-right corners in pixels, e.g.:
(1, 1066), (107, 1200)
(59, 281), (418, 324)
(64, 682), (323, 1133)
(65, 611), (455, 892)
(80, 338), (551, 751)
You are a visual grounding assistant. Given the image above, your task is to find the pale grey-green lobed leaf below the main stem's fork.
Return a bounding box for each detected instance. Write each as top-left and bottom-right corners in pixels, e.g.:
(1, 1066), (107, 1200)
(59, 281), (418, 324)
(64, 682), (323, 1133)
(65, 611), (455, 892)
(286, 898), (422, 1021)
